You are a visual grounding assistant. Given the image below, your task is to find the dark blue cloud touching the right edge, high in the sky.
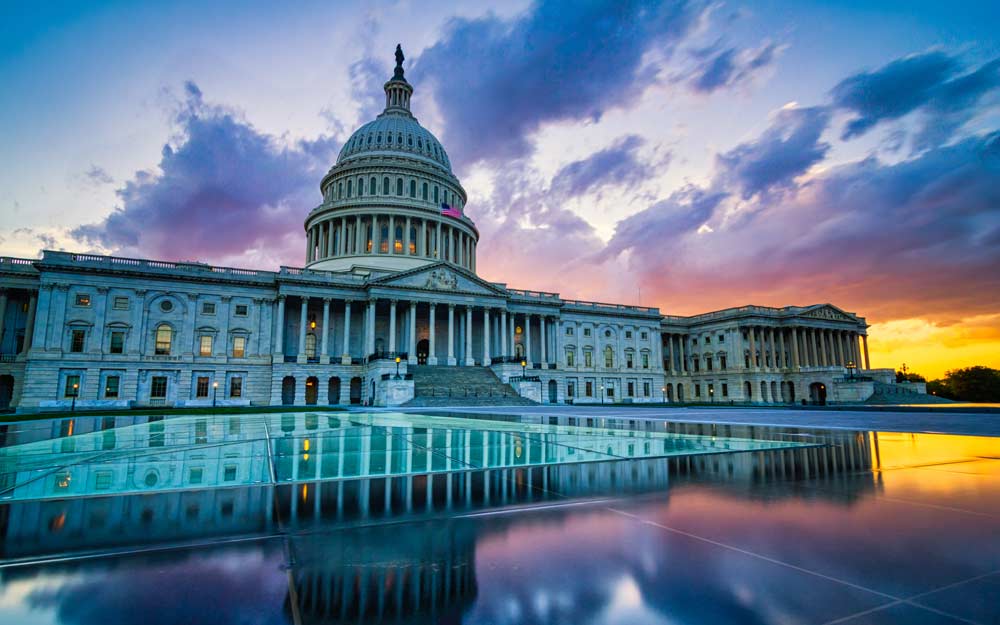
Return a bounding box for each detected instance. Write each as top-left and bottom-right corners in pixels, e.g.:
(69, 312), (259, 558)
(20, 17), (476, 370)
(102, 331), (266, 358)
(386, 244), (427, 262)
(831, 51), (1000, 149)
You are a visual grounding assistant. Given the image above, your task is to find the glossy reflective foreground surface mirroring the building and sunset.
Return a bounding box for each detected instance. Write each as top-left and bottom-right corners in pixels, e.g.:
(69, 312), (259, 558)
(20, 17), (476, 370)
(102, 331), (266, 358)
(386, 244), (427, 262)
(0, 412), (1000, 624)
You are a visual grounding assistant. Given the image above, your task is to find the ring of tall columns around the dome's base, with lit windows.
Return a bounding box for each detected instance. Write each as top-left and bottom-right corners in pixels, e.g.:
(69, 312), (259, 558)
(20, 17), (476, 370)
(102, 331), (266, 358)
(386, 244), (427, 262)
(306, 215), (476, 271)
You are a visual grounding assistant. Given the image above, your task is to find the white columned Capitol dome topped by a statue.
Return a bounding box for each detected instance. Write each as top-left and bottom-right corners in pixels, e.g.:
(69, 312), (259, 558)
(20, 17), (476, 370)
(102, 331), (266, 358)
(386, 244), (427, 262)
(305, 46), (479, 273)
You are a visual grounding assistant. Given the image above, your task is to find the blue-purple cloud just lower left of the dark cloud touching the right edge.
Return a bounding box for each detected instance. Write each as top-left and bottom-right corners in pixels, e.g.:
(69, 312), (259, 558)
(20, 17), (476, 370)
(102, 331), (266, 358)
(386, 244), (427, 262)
(716, 107), (830, 199)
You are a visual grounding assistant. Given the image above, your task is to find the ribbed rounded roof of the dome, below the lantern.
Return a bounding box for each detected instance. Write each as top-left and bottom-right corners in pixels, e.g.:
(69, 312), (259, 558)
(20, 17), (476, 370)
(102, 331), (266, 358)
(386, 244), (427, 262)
(337, 112), (451, 173)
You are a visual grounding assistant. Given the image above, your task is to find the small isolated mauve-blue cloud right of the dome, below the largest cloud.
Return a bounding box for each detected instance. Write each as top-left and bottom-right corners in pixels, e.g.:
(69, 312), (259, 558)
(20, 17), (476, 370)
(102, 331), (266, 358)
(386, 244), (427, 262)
(551, 135), (654, 198)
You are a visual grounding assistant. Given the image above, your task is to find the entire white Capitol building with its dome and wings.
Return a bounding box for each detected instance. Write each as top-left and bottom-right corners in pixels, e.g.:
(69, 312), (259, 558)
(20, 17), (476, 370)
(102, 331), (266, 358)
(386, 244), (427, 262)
(0, 48), (920, 410)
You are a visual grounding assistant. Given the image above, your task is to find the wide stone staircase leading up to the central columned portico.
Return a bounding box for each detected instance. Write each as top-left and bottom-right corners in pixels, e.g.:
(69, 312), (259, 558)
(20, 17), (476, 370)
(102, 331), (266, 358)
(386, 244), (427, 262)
(403, 365), (535, 407)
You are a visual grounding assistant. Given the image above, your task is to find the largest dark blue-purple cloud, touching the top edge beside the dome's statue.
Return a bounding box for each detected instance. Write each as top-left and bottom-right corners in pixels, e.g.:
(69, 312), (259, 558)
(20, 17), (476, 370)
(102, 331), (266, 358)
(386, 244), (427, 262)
(414, 0), (702, 165)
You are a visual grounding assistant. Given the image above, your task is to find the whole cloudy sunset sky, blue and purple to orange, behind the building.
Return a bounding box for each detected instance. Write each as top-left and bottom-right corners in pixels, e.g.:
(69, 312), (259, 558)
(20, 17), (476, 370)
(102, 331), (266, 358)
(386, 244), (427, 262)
(0, 0), (1000, 377)
